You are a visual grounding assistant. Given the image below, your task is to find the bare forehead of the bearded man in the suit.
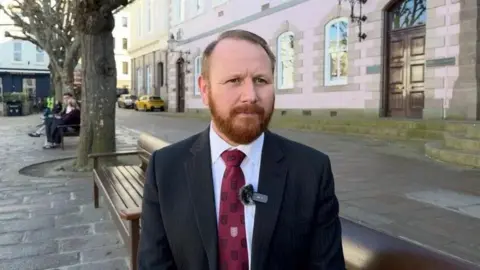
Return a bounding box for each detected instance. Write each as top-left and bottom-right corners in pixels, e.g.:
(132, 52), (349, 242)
(210, 39), (271, 75)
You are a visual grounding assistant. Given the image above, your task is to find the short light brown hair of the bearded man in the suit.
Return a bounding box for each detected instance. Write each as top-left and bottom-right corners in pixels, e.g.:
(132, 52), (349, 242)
(202, 29), (276, 79)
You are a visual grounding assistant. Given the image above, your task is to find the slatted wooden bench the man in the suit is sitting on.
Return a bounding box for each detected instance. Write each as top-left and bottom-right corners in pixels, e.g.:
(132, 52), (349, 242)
(90, 134), (480, 270)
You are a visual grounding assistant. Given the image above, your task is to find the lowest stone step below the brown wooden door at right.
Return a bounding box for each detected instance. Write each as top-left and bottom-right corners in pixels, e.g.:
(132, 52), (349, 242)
(425, 142), (480, 168)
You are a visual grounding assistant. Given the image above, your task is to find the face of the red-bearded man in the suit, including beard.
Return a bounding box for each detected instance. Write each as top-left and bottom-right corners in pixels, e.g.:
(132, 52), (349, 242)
(198, 39), (275, 144)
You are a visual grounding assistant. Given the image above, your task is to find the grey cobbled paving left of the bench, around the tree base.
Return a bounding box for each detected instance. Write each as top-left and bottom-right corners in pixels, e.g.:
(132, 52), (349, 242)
(0, 115), (137, 270)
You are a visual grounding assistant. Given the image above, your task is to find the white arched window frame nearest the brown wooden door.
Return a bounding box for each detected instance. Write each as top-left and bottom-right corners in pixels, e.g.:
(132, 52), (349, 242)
(323, 17), (350, 86)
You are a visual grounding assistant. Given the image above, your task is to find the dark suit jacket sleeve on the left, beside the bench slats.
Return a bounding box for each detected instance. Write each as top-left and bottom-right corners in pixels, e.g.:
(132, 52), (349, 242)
(138, 152), (176, 270)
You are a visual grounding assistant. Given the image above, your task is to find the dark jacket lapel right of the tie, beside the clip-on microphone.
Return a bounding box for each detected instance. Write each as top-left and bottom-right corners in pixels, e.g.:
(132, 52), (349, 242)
(252, 132), (287, 270)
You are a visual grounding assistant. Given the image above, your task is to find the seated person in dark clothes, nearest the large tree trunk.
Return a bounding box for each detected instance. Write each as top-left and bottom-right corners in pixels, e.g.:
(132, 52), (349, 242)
(43, 98), (80, 149)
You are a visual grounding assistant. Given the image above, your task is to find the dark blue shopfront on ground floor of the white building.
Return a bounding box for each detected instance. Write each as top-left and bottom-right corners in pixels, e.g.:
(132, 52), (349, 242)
(0, 69), (50, 98)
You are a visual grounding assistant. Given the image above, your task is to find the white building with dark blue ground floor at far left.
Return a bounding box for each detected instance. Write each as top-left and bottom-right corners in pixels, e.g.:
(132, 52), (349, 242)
(0, 6), (50, 97)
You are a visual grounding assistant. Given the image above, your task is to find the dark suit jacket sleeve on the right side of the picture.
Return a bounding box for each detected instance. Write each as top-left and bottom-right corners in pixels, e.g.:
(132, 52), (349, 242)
(308, 156), (346, 270)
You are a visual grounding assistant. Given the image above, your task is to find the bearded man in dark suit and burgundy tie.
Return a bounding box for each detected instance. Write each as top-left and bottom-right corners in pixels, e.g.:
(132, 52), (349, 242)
(138, 30), (345, 270)
